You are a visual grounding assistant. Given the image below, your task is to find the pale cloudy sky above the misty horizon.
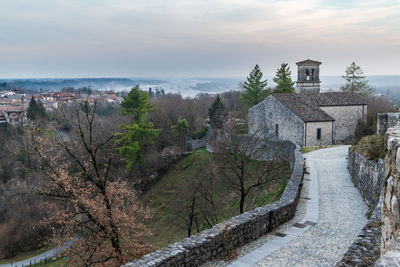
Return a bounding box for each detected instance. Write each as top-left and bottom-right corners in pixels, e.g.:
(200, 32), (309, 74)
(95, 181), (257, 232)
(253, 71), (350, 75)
(0, 0), (400, 78)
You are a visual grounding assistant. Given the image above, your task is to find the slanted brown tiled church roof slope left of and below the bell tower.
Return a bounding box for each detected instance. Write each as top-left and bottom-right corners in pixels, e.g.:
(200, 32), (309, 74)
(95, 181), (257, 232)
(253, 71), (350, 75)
(272, 94), (334, 122)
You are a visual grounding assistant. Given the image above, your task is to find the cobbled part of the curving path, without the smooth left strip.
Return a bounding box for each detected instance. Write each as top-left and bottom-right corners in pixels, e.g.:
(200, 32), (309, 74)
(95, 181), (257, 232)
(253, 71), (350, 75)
(256, 146), (367, 266)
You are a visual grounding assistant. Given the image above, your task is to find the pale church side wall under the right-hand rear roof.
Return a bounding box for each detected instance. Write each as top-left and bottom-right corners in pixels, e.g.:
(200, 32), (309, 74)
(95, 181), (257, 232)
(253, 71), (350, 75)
(320, 105), (367, 144)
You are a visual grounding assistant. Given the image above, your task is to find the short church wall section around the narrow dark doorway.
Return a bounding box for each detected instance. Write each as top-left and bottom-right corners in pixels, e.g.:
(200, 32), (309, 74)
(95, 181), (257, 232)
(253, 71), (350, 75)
(305, 121), (333, 146)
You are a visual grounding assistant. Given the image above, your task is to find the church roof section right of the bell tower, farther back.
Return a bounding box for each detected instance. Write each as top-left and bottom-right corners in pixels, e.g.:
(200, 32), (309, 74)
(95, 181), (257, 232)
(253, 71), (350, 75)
(308, 92), (367, 107)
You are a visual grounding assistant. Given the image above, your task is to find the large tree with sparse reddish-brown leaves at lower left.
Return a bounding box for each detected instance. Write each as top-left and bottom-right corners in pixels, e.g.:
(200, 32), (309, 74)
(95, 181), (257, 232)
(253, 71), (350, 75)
(29, 101), (150, 266)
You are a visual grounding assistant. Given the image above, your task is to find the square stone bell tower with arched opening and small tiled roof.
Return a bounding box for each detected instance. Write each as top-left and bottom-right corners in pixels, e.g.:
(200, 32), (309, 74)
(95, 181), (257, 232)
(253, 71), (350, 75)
(296, 59), (321, 94)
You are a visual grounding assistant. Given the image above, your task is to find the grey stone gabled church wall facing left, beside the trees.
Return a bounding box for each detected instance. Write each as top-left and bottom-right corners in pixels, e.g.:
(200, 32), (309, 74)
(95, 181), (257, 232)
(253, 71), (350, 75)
(249, 96), (304, 146)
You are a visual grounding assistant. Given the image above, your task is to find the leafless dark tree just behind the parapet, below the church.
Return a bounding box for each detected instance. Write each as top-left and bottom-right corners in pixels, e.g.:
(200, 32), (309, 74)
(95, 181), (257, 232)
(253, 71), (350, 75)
(211, 118), (284, 213)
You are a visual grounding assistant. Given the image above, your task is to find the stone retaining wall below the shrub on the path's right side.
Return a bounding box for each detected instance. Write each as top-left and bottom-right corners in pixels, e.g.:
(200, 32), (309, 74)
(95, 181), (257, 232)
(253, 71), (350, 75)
(348, 151), (385, 208)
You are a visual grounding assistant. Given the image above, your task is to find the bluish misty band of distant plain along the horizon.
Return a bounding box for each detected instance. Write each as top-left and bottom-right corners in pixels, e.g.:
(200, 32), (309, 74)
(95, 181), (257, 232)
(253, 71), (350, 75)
(0, 74), (400, 97)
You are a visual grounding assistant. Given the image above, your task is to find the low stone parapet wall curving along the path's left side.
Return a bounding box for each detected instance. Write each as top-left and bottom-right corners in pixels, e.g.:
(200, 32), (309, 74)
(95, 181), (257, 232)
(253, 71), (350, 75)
(125, 143), (304, 267)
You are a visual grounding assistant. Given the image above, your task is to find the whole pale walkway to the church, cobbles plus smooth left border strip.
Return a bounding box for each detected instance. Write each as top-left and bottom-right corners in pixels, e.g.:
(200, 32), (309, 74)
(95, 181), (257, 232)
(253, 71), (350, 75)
(207, 146), (367, 267)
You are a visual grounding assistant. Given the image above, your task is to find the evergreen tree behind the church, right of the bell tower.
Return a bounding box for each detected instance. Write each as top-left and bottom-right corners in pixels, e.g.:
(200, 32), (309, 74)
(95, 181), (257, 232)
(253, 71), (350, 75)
(341, 62), (375, 96)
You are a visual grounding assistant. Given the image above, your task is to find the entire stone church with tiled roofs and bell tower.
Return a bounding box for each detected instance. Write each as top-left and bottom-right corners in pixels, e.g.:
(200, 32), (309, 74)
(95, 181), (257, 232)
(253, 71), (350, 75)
(249, 59), (367, 146)
